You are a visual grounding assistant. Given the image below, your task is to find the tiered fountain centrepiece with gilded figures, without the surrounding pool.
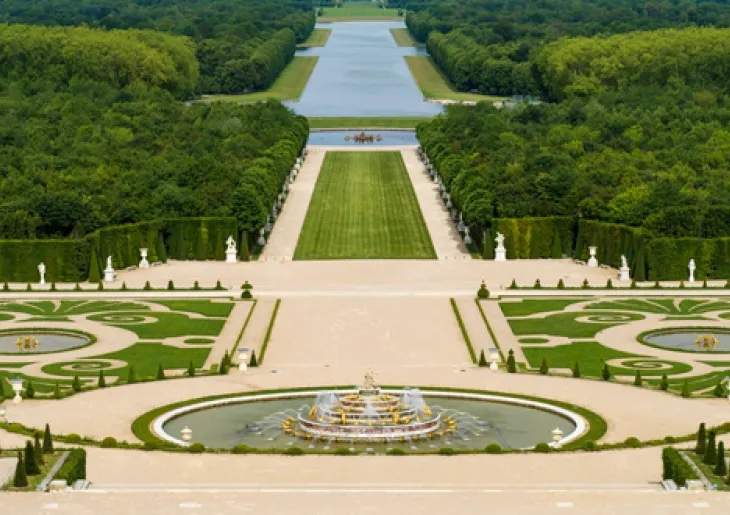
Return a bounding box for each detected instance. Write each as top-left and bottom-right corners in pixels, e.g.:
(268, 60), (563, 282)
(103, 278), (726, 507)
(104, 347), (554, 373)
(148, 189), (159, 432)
(282, 374), (450, 442)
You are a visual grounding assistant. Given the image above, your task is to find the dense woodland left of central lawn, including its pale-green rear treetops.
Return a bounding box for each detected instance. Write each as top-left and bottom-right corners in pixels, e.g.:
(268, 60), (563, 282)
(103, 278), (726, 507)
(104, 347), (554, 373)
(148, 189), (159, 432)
(0, 22), (308, 239)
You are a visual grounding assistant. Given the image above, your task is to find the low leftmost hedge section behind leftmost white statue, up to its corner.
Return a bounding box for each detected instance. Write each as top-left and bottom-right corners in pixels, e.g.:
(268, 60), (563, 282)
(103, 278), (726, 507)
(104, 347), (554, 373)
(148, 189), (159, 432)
(0, 240), (89, 283)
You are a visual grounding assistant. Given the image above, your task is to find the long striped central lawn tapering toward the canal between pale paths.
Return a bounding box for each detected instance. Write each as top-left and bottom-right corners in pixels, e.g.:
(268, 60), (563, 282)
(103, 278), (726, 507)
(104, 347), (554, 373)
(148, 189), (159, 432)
(294, 152), (436, 259)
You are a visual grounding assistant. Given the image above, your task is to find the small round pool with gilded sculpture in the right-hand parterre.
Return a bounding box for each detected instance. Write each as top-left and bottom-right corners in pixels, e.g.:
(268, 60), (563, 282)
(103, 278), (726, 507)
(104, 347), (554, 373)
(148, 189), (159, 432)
(639, 327), (730, 353)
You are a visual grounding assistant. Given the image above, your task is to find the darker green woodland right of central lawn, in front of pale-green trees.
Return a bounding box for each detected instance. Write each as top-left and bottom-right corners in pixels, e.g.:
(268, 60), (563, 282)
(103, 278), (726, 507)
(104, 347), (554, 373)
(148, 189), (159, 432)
(418, 85), (730, 238)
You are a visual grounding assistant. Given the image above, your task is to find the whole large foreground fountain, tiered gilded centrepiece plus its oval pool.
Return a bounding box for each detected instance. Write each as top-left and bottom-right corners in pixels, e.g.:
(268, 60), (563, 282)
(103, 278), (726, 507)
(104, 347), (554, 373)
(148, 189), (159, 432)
(151, 376), (596, 453)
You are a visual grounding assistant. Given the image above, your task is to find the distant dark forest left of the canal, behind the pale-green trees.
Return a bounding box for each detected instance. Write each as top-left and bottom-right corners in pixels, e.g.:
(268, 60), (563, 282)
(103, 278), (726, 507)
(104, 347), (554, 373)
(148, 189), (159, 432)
(0, 0), (315, 93)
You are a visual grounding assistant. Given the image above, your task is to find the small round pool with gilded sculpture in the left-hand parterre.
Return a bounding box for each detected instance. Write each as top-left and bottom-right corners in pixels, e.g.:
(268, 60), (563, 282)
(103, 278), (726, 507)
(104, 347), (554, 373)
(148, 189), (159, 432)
(0, 328), (95, 355)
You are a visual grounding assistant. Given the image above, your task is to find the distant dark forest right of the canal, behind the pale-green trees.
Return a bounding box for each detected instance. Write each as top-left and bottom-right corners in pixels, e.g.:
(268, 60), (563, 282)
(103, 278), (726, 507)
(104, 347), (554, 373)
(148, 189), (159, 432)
(406, 0), (730, 95)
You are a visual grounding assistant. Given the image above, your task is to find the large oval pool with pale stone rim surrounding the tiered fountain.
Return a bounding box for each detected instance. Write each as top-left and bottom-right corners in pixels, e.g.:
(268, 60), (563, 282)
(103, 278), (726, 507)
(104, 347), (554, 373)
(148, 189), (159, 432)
(151, 389), (588, 453)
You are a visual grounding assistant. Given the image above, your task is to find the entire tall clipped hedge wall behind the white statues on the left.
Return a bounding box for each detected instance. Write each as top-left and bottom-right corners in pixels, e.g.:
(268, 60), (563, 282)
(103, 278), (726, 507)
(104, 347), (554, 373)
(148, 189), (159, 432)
(0, 217), (249, 282)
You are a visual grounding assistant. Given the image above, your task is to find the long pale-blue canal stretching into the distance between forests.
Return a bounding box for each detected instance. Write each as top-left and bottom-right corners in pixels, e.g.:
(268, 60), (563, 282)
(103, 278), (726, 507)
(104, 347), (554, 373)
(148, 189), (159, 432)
(287, 22), (443, 116)
